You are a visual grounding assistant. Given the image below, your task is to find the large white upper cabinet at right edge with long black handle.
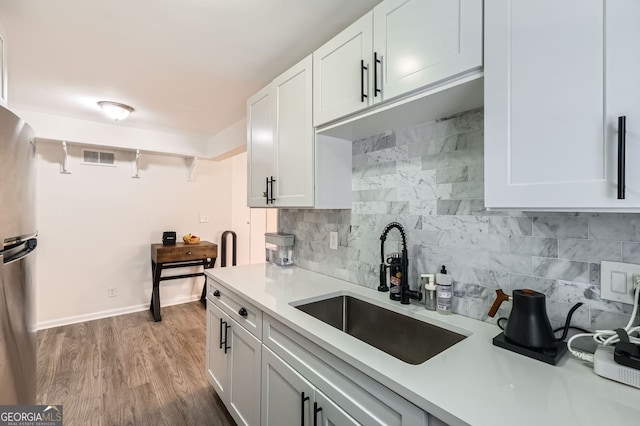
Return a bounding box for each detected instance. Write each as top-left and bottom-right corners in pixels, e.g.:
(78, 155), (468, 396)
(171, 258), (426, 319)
(485, 0), (640, 211)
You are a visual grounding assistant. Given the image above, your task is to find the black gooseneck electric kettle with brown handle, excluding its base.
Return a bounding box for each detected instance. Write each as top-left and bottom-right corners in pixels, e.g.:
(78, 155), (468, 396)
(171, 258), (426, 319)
(489, 289), (582, 349)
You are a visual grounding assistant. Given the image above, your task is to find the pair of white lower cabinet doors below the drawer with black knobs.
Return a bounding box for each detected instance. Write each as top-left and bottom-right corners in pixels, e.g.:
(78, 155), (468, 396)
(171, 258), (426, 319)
(207, 301), (261, 425)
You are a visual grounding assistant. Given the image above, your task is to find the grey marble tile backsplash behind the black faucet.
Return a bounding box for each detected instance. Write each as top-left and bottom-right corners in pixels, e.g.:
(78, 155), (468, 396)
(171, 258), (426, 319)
(279, 109), (640, 329)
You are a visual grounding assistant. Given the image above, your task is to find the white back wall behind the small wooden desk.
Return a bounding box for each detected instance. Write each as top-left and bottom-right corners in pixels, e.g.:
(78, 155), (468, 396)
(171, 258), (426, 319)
(36, 142), (232, 328)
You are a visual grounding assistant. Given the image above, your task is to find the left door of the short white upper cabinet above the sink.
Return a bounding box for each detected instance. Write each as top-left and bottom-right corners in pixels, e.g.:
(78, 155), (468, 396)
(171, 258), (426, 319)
(313, 12), (373, 126)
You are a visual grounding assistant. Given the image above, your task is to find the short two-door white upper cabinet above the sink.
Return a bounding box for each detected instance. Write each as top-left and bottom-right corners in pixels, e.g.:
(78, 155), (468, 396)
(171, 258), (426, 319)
(313, 0), (482, 127)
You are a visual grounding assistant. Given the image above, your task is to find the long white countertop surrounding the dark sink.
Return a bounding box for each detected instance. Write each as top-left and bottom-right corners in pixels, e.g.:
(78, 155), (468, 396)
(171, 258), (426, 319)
(205, 264), (640, 426)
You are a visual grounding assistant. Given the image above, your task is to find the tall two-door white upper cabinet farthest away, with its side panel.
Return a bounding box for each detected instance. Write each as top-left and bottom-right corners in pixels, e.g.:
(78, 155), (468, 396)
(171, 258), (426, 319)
(247, 55), (352, 209)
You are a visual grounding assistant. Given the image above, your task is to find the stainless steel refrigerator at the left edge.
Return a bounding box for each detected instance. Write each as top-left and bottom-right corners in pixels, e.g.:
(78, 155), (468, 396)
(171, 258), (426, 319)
(0, 107), (37, 405)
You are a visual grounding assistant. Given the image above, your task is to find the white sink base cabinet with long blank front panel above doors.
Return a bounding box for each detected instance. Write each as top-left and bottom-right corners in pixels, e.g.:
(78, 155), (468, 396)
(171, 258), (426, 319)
(262, 315), (429, 426)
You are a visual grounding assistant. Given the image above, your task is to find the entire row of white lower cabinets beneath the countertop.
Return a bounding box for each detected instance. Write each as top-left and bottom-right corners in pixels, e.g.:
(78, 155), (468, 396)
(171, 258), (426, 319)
(206, 280), (442, 426)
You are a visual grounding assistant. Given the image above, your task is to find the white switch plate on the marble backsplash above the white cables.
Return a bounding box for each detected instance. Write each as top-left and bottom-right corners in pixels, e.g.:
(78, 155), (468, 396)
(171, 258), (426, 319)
(600, 261), (640, 305)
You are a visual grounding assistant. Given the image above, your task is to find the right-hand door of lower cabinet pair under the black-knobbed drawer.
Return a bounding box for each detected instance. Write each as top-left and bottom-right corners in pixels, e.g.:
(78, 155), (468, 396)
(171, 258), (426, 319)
(227, 319), (262, 426)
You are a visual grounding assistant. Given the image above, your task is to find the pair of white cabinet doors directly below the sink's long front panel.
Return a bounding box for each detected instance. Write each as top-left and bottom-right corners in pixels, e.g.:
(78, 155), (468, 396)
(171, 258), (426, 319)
(262, 346), (360, 426)
